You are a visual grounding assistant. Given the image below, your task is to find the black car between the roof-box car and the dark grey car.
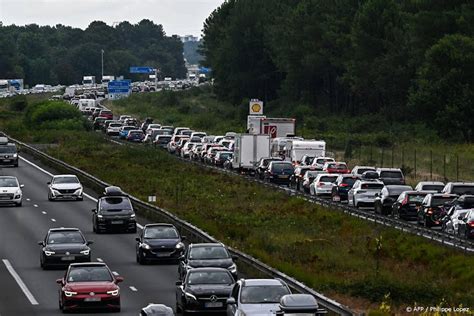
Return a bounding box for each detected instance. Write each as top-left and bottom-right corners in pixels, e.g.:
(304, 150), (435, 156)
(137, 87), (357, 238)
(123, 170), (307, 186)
(135, 223), (185, 264)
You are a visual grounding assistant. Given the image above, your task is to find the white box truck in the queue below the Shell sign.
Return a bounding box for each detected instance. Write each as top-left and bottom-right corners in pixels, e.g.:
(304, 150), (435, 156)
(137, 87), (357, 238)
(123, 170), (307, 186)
(232, 134), (270, 171)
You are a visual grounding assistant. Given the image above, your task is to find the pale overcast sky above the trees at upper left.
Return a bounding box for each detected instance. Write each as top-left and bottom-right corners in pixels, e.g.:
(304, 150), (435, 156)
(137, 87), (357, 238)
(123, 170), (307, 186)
(0, 0), (224, 36)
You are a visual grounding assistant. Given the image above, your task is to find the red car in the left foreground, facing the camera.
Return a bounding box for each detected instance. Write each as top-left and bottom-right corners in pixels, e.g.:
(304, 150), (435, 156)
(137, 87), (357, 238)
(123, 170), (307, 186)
(56, 262), (123, 312)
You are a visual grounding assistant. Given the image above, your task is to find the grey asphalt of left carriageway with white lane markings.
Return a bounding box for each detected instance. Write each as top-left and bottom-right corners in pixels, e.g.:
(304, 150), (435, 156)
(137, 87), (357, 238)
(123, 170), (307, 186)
(0, 156), (177, 316)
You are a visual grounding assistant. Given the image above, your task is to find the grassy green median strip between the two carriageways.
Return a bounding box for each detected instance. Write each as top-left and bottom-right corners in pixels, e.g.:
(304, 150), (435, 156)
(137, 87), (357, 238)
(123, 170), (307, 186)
(0, 92), (474, 312)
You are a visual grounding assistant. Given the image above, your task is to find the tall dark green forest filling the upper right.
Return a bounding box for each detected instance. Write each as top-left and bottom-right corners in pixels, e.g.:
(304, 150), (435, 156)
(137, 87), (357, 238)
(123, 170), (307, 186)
(201, 0), (474, 141)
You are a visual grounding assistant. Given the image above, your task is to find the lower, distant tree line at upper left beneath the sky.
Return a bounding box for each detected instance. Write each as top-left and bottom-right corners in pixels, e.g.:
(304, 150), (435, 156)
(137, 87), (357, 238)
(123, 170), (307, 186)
(0, 20), (186, 85)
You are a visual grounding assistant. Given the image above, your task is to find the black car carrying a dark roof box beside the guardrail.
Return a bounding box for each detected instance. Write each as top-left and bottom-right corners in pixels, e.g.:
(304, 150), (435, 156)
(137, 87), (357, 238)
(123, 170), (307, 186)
(92, 187), (137, 233)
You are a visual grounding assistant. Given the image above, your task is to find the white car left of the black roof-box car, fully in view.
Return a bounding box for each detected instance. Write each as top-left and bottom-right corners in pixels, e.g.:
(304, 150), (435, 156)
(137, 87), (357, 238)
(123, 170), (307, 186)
(48, 174), (83, 201)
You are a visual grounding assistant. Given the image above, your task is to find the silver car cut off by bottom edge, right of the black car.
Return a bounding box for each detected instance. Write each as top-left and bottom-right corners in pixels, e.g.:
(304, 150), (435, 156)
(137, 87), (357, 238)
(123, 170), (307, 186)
(227, 279), (291, 316)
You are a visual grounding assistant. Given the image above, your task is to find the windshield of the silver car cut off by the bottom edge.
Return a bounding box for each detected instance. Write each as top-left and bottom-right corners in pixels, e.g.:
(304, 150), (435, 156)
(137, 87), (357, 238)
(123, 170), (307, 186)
(240, 285), (290, 304)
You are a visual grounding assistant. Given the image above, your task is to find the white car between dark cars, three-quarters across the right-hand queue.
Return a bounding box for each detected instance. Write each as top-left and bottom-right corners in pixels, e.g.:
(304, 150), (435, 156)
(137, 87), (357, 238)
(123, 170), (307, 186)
(347, 180), (384, 208)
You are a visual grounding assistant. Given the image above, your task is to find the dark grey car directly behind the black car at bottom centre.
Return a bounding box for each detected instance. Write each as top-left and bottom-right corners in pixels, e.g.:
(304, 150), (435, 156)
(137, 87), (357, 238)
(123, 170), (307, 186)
(178, 243), (237, 280)
